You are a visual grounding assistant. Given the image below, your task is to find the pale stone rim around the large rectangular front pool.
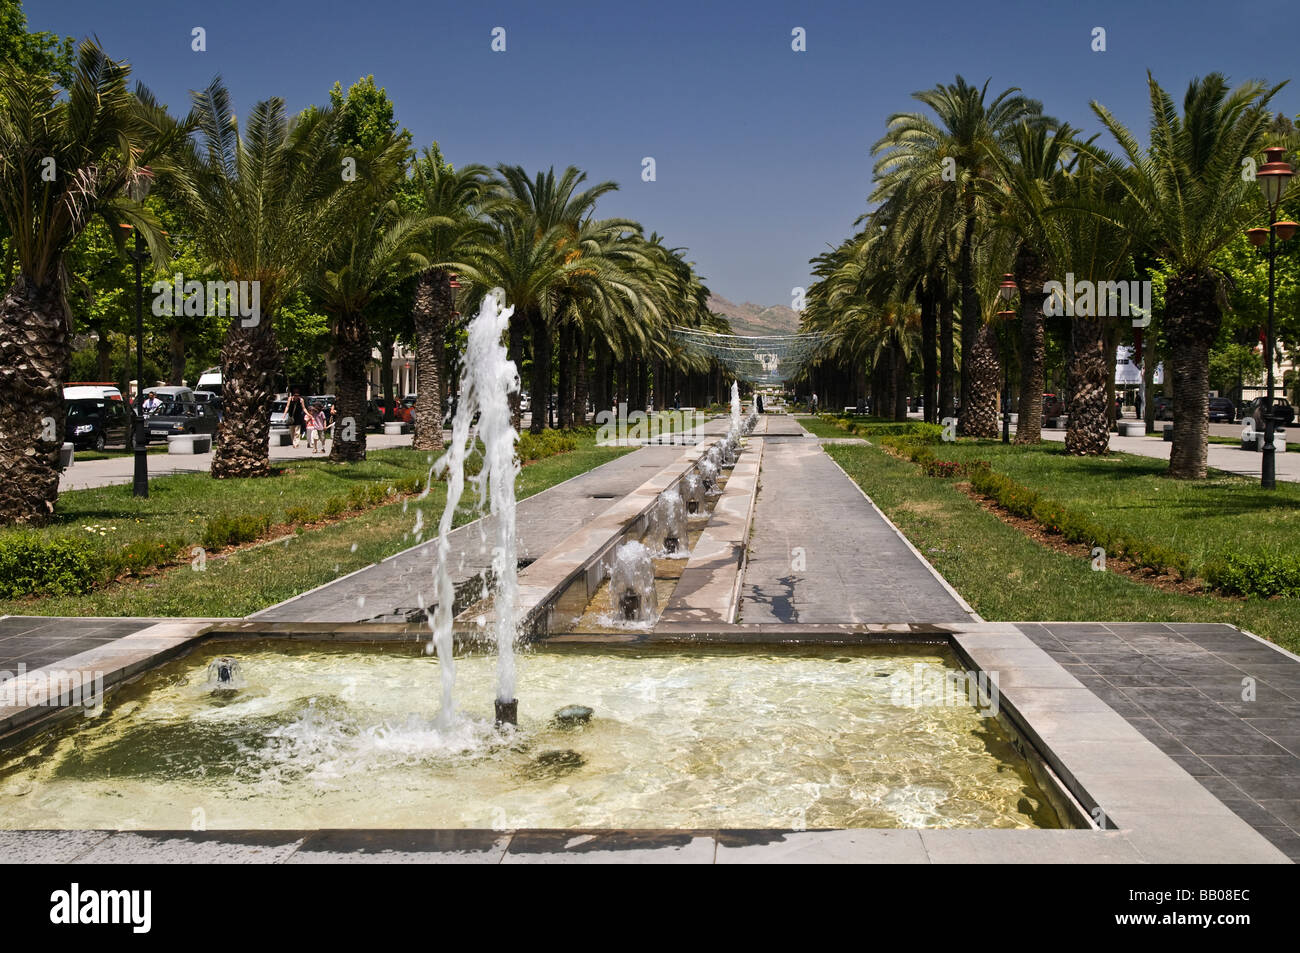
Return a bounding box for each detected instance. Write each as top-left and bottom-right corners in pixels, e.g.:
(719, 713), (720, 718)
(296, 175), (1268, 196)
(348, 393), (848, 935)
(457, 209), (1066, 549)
(0, 620), (1290, 863)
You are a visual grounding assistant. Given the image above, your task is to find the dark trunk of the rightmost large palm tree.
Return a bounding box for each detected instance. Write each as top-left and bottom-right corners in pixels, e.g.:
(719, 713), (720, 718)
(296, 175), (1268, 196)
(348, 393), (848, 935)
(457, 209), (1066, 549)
(1165, 272), (1223, 480)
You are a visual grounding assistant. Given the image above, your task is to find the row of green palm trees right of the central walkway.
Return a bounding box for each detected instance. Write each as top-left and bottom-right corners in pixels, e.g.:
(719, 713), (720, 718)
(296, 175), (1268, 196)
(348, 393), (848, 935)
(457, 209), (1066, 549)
(803, 74), (1296, 478)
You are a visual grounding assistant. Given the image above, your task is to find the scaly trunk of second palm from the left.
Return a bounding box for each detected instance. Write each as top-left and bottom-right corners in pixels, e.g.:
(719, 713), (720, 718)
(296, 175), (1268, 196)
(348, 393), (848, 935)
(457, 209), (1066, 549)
(212, 312), (280, 480)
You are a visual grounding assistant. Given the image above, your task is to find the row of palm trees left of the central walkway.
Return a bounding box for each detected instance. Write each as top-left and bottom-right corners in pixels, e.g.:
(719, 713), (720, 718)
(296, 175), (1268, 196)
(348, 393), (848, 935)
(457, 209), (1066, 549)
(0, 42), (715, 523)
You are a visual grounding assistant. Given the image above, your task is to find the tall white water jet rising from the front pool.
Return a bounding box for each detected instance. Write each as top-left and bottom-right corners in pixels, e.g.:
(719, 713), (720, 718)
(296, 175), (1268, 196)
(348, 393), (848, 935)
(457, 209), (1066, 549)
(429, 287), (519, 729)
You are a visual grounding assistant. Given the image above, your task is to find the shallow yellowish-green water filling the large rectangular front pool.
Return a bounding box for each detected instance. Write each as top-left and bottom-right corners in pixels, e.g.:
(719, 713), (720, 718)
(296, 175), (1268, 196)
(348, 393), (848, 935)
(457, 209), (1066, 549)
(0, 640), (1075, 829)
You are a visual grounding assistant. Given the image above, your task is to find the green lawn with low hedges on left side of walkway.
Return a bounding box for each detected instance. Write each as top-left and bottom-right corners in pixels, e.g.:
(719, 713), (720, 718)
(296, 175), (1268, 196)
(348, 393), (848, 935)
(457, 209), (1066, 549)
(0, 433), (631, 616)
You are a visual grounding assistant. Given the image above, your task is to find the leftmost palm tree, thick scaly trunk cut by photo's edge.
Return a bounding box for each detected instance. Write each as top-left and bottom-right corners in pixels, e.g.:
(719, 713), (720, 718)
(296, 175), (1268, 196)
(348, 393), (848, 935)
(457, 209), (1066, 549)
(0, 40), (185, 523)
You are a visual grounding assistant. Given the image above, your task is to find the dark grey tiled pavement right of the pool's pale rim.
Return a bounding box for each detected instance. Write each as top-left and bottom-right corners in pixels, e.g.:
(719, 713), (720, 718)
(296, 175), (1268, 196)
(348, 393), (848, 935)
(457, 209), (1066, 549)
(1017, 623), (1300, 862)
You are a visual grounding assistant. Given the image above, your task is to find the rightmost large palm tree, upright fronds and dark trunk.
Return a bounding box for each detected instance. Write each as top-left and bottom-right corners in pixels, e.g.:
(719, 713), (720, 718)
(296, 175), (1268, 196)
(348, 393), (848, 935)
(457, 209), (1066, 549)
(1092, 73), (1281, 480)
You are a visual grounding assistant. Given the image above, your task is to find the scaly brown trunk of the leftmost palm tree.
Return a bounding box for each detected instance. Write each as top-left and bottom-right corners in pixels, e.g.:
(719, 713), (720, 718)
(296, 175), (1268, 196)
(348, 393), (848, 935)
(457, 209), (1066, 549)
(0, 274), (72, 524)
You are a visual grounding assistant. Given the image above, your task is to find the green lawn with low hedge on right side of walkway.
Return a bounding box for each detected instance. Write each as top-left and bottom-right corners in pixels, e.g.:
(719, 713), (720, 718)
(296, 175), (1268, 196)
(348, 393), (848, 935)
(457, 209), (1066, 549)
(826, 443), (1300, 651)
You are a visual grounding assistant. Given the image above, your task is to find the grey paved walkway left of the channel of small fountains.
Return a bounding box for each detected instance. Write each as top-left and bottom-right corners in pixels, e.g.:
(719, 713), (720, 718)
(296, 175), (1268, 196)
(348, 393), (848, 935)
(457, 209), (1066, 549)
(250, 431), (724, 623)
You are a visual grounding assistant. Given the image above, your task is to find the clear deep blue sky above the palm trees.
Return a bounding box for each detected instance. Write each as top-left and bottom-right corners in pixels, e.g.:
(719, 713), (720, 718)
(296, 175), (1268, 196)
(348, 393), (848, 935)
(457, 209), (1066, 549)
(25, 0), (1300, 304)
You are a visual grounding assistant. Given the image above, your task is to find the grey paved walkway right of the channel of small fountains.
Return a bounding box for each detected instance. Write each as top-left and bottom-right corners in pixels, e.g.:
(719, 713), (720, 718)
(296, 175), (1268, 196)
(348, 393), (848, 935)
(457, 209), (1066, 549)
(740, 416), (974, 623)
